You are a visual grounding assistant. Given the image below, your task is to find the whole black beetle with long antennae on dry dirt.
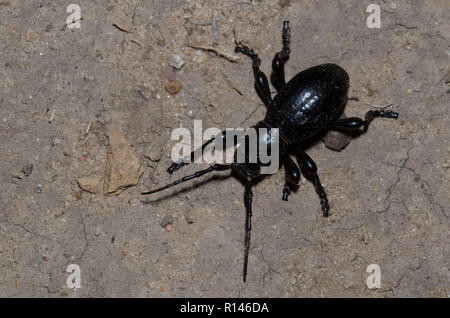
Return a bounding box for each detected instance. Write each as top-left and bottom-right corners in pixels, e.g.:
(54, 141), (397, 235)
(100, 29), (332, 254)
(142, 21), (398, 282)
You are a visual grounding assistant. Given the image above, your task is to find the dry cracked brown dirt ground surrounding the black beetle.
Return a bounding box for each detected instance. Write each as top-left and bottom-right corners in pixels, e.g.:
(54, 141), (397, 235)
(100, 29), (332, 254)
(0, 0), (450, 297)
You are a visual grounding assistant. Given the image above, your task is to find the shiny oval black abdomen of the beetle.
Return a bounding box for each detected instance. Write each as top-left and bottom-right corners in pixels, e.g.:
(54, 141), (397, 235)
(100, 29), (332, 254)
(264, 64), (349, 144)
